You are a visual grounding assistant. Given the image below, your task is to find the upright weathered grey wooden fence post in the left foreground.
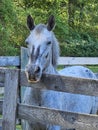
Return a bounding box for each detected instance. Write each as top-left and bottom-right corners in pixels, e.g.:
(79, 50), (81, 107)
(2, 69), (19, 130)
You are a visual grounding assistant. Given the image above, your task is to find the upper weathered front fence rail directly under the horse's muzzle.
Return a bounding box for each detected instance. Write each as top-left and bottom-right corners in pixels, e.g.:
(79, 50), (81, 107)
(20, 71), (98, 96)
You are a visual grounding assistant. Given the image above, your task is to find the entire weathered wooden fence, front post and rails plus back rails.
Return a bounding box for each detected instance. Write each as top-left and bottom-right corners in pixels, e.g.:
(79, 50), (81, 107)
(0, 47), (98, 130)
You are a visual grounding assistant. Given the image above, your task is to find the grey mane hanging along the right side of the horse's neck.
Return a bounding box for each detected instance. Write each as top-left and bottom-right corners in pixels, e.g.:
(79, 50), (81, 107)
(52, 32), (60, 68)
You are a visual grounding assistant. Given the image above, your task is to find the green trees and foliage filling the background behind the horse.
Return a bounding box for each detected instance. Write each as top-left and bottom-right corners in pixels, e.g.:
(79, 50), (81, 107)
(0, 0), (98, 56)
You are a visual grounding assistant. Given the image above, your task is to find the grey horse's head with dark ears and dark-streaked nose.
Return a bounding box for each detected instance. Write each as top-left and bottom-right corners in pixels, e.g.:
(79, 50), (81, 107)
(25, 15), (59, 82)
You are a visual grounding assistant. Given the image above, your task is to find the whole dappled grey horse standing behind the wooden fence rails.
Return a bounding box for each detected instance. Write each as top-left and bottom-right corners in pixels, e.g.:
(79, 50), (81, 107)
(23, 15), (97, 130)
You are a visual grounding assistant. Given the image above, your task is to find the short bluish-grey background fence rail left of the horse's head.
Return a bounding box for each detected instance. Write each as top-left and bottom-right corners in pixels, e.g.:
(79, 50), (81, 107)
(0, 56), (20, 66)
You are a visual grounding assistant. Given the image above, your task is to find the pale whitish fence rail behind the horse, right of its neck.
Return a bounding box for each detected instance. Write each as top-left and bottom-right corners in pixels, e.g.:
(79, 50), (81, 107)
(58, 57), (98, 65)
